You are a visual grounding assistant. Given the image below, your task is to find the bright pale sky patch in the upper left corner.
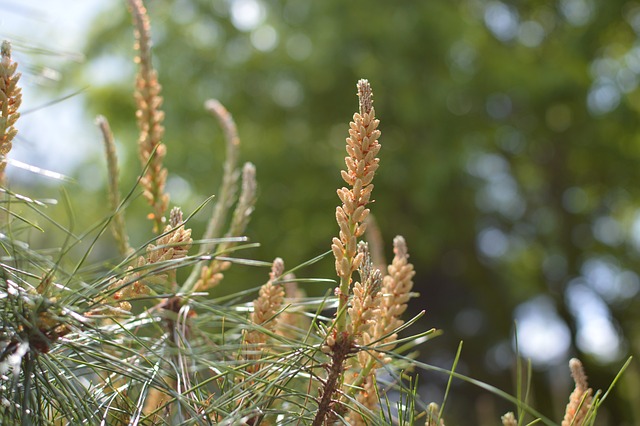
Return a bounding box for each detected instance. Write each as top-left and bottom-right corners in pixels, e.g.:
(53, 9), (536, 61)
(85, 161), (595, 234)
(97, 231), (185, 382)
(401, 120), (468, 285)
(0, 0), (113, 182)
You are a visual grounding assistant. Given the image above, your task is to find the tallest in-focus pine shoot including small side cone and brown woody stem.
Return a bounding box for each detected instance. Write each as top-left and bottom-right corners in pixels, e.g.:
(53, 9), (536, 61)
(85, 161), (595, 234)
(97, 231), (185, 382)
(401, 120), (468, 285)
(312, 79), (380, 426)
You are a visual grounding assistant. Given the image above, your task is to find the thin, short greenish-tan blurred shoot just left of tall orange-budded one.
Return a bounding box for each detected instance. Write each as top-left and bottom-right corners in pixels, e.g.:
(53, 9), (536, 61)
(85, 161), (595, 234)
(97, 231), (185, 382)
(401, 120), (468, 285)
(96, 115), (132, 256)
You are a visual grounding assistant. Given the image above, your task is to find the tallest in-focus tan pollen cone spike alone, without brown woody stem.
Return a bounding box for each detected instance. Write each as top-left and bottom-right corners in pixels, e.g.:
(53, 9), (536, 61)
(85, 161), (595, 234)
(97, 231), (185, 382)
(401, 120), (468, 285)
(331, 79), (380, 332)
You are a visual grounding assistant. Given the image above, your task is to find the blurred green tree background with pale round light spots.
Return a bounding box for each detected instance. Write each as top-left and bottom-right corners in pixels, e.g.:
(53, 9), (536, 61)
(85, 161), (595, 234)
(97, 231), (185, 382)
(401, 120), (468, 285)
(5, 0), (640, 425)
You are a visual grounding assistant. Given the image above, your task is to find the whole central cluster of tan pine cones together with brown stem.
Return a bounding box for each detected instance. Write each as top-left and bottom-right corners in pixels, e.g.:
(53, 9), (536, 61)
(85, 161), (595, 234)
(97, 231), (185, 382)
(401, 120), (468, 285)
(313, 80), (414, 426)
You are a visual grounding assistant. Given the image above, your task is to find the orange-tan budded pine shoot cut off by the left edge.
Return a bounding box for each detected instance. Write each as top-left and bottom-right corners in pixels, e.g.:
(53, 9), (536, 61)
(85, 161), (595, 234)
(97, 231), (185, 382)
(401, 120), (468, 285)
(0, 40), (22, 184)
